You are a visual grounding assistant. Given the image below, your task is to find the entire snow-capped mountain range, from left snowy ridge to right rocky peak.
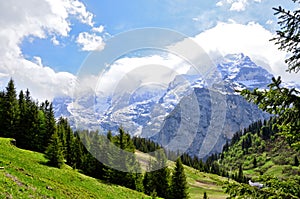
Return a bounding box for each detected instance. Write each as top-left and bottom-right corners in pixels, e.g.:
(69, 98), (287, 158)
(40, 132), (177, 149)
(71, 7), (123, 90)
(54, 54), (292, 157)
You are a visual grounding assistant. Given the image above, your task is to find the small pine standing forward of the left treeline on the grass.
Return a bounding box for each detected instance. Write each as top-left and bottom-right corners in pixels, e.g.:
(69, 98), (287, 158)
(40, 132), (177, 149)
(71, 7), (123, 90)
(45, 132), (64, 168)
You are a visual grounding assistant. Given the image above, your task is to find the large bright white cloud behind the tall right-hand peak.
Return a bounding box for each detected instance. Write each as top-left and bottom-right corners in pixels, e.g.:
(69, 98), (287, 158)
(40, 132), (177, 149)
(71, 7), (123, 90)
(194, 22), (299, 82)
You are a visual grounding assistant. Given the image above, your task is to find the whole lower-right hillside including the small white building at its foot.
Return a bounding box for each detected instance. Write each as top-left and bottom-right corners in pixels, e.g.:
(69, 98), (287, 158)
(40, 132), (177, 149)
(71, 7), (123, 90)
(213, 119), (300, 199)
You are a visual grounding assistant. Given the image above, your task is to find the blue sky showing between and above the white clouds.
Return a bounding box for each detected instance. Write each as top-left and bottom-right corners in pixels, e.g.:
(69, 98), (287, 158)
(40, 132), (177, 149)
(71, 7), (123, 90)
(22, 0), (295, 74)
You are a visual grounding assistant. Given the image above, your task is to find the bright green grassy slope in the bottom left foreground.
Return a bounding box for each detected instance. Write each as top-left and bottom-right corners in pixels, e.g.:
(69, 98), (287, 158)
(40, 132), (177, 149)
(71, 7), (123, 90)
(0, 138), (150, 199)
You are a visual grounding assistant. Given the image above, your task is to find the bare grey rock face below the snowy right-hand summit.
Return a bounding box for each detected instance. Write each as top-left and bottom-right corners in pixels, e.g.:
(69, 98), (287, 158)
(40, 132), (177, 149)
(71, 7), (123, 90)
(152, 88), (269, 158)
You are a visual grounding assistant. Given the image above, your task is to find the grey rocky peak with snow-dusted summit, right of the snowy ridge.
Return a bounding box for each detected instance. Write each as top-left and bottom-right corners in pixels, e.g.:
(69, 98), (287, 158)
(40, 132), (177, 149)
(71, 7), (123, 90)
(149, 54), (272, 158)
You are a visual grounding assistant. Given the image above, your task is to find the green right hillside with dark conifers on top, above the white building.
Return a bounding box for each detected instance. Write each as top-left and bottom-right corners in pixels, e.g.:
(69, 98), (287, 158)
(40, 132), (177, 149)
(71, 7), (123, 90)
(219, 121), (300, 179)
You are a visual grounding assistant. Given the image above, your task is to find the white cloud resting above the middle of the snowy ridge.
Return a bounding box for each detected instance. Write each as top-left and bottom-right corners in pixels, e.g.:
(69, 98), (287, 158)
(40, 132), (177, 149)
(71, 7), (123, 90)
(96, 54), (191, 95)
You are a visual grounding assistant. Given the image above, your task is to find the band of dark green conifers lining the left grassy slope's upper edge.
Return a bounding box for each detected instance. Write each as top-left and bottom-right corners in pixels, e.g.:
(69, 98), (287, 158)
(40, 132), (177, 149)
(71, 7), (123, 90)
(0, 79), (188, 198)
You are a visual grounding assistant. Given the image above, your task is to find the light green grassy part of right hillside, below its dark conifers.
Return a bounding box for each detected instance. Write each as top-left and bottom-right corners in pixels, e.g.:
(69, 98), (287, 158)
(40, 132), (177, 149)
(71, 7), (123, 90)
(220, 134), (300, 180)
